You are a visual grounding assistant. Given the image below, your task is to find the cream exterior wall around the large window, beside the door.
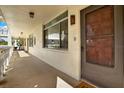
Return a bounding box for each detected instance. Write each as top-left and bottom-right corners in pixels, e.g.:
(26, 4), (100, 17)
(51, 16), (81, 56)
(27, 6), (86, 80)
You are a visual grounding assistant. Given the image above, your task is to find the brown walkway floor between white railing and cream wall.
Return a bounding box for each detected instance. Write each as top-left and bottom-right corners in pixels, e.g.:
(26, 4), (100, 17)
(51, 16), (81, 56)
(0, 52), (78, 88)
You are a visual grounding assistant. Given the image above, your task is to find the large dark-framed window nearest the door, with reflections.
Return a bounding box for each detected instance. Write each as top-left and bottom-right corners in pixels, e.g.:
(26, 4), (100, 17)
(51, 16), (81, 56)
(44, 10), (68, 49)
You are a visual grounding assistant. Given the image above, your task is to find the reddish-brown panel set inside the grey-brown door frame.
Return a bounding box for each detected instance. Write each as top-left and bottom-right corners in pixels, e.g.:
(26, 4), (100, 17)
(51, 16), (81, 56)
(85, 6), (114, 66)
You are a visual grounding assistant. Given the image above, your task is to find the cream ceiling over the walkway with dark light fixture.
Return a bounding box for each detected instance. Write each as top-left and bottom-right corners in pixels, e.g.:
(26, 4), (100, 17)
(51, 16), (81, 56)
(0, 5), (67, 37)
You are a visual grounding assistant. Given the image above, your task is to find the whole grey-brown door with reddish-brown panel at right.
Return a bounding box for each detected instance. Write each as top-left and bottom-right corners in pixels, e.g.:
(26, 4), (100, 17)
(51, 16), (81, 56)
(81, 6), (123, 87)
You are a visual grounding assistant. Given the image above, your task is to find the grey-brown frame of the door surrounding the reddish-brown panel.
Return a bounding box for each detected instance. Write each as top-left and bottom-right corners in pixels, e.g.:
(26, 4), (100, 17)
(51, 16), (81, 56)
(80, 5), (124, 87)
